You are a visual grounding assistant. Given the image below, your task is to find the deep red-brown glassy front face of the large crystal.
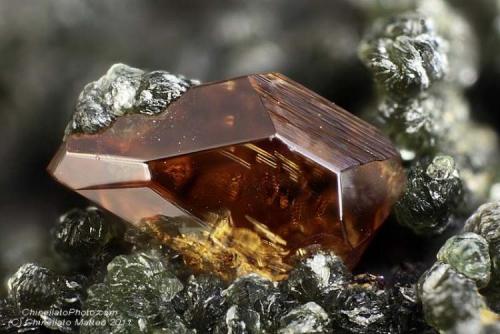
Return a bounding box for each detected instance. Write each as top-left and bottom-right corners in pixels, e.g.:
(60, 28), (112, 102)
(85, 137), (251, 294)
(150, 138), (350, 255)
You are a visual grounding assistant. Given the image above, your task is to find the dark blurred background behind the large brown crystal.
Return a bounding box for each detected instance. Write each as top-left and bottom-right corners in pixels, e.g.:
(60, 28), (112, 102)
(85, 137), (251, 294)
(0, 0), (500, 288)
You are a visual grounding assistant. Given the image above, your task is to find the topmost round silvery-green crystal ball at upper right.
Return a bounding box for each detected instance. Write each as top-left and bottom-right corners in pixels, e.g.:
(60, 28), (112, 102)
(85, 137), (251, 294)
(359, 14), (448, 96)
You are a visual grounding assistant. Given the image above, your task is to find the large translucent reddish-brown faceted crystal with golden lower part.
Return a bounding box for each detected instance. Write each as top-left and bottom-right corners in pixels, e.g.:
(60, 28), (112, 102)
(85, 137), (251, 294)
(49, 73), (405, 279)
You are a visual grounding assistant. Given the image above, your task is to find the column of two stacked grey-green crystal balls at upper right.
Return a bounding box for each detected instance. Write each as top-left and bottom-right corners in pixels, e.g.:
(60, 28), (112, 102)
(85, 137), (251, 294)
(359, 12), (448, 161)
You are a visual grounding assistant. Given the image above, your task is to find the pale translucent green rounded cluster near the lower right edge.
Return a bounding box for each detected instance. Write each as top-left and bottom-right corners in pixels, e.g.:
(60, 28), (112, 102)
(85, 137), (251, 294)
(437, 232), (491, 288)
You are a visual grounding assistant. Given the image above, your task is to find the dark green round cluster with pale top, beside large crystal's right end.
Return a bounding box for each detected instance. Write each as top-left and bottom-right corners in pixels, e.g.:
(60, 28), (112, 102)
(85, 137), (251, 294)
(395, 156), (462, 235)
